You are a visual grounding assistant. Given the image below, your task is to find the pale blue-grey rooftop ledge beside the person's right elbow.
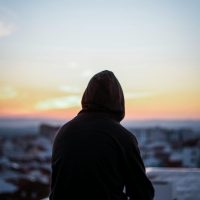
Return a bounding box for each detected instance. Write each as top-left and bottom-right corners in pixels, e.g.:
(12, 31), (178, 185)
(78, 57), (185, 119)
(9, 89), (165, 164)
(43, 167), (200, 200)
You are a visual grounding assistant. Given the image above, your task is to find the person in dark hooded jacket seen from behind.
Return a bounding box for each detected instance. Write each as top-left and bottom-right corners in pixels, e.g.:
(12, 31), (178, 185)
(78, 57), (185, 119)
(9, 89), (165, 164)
(50, 70), (154, 200)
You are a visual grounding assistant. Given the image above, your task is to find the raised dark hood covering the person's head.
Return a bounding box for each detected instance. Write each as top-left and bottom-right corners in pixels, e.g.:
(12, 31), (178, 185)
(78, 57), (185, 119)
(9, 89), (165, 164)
(81, 70), (125, 121)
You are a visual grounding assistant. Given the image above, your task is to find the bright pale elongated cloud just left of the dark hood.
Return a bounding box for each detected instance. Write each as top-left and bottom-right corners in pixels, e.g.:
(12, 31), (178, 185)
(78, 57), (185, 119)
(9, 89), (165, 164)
(36, 95), (81, 110)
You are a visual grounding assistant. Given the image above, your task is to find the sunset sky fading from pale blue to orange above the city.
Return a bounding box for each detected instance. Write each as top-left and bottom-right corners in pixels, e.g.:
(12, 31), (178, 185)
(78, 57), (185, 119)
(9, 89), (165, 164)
(0, 0), (200, 119)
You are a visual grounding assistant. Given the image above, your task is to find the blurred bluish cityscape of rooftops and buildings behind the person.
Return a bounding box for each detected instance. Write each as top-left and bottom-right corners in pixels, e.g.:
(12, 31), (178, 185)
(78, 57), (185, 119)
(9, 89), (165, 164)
(0, 121), (200, 200)
